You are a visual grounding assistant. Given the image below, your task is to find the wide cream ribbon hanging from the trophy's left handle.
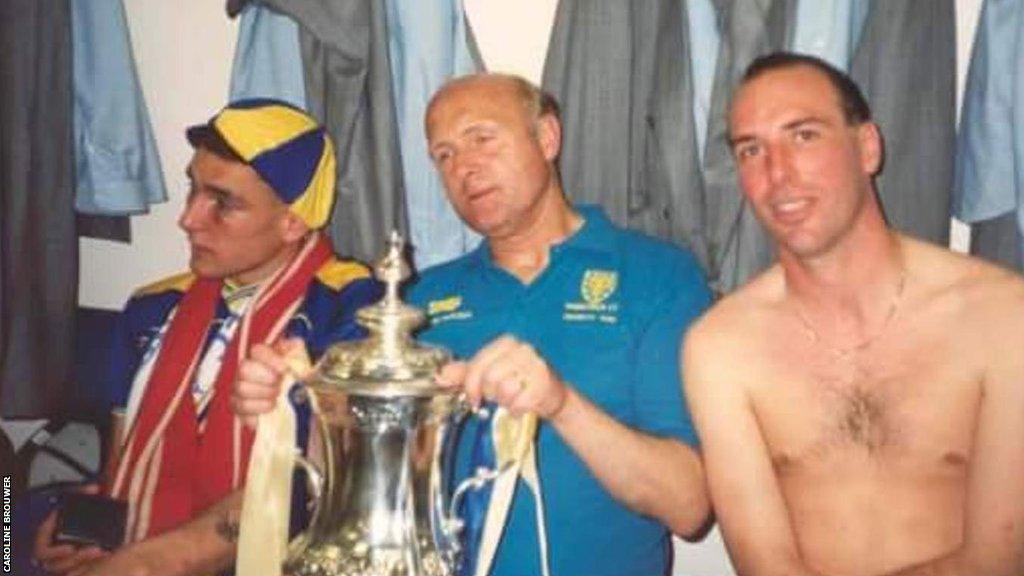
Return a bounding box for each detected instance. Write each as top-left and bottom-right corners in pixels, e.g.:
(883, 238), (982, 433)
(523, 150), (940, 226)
(234, 347), (310, 576)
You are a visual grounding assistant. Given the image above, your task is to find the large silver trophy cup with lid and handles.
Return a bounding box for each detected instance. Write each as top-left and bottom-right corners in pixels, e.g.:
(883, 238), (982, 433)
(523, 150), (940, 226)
(284, 233), (499, 576)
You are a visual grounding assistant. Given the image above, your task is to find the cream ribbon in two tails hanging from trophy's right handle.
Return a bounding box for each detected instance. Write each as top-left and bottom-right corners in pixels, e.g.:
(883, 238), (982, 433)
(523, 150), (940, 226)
(476, 408), (551, 576)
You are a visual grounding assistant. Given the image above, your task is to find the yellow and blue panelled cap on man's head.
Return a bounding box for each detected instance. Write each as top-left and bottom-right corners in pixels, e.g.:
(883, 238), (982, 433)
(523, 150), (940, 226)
(185, 98), (336, 230)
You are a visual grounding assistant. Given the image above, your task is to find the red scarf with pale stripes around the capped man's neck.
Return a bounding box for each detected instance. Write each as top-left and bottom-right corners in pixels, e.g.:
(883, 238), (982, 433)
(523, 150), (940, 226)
(110, 235), (333, 542)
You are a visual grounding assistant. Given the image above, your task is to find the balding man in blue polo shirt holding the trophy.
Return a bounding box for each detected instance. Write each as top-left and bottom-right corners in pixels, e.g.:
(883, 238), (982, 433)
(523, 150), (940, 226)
(237, 74), (710, 576)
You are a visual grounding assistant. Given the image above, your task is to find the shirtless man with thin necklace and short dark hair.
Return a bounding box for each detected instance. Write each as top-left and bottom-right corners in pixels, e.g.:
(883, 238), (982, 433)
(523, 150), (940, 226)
(684, 50), (1024, 576)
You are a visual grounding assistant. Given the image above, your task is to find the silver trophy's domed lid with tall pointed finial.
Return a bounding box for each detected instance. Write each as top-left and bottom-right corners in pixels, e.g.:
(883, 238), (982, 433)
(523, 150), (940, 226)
(307, 232), (452, 397)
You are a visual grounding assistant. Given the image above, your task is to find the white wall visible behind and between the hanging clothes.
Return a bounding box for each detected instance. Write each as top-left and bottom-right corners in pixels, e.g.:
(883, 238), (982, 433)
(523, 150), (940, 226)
(79, 0), (982, 576)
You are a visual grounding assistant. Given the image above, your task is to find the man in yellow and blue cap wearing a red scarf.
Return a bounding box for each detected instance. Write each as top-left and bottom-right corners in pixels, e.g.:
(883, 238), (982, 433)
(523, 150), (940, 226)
(35, 99), (379, 576)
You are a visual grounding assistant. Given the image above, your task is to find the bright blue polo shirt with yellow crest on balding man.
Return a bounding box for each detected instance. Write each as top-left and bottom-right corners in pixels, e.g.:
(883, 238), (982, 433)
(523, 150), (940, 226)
(408, 207), (711, 576)
